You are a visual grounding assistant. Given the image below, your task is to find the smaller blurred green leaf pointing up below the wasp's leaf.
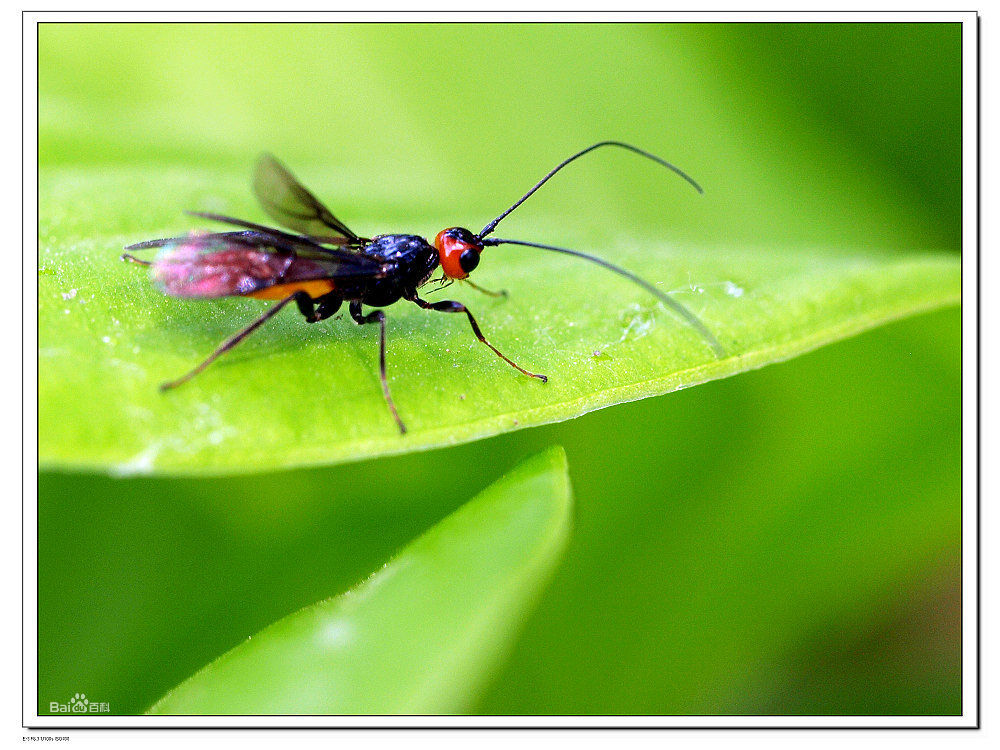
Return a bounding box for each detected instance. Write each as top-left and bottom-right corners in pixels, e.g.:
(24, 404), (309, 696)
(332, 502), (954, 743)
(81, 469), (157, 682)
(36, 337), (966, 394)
(148, 448), (572, 714)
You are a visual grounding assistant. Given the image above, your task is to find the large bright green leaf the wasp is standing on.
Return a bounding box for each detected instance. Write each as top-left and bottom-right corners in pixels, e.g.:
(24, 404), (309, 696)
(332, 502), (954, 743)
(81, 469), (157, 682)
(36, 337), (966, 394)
(38, 168), (960, 474)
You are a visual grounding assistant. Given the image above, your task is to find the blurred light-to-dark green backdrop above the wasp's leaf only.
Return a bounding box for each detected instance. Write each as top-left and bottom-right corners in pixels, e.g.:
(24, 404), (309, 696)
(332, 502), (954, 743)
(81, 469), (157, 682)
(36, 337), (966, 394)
(38, 23), (962, 252)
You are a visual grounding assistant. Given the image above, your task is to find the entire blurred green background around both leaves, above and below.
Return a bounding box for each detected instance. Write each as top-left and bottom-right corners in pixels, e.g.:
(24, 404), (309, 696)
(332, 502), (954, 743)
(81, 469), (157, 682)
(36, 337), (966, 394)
(38, 24), (961, 714)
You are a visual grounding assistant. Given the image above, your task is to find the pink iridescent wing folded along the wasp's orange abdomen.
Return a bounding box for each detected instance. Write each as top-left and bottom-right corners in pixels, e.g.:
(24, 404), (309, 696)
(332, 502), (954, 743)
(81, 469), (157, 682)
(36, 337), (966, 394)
(137, 230), (394, 298)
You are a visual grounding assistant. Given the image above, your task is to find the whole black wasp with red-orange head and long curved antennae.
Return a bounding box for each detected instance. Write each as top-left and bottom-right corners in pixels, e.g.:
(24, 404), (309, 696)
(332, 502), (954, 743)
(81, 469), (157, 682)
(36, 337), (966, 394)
(122, 141), (725, 433)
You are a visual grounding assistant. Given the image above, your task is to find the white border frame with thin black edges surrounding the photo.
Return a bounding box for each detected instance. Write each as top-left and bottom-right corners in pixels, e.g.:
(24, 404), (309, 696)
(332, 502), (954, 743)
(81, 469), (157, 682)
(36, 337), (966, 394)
(22, 11), (979, 739)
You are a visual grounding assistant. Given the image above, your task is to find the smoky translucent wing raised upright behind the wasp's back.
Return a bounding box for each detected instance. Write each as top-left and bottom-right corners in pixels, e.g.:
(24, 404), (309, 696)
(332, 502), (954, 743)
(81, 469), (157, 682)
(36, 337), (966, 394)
(253, 154), (362, 245)
